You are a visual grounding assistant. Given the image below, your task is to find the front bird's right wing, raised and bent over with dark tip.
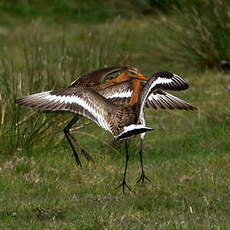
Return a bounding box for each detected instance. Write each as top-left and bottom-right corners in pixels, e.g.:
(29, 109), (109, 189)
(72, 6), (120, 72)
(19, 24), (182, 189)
(139, 72), (192, 117)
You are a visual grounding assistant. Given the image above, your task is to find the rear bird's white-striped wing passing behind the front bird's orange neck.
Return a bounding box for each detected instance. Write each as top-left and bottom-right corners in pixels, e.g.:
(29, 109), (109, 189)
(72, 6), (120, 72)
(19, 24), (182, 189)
(98, 81), (196, 110)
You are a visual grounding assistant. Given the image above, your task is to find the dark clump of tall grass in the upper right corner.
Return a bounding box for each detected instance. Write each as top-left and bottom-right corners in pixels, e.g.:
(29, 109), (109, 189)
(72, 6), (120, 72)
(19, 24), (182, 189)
(154, 0), (230, 70)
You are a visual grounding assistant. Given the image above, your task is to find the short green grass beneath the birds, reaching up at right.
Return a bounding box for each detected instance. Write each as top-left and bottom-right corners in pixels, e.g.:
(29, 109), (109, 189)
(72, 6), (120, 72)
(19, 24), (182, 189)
(0, 69), (230, 229)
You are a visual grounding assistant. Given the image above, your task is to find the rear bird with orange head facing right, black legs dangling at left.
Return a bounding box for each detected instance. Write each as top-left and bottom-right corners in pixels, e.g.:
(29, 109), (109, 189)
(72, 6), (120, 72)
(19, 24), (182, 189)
(64, 66), (194, 171)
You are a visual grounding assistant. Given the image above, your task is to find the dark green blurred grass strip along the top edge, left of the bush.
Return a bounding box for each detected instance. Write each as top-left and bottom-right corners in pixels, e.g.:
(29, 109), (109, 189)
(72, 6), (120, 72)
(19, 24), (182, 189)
(0, 0), (187, 26)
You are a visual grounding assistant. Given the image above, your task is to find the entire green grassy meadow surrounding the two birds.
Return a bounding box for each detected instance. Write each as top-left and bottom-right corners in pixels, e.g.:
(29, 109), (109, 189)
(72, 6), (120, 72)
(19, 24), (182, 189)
(0, 0), (230, 230)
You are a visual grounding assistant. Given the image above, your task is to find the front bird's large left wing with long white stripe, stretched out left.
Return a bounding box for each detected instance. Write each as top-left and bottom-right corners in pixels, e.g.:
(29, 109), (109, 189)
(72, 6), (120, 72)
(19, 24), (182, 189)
(16, 87), (114, 132)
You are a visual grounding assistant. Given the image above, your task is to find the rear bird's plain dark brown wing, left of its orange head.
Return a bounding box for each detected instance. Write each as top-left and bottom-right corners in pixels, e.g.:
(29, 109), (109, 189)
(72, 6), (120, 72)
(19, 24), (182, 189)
(70, 66), (128, 87)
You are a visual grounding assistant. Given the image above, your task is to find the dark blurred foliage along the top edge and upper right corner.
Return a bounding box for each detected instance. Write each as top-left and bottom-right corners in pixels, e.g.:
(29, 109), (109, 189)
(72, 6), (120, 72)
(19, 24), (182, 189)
(0, 0), (230, 70)
